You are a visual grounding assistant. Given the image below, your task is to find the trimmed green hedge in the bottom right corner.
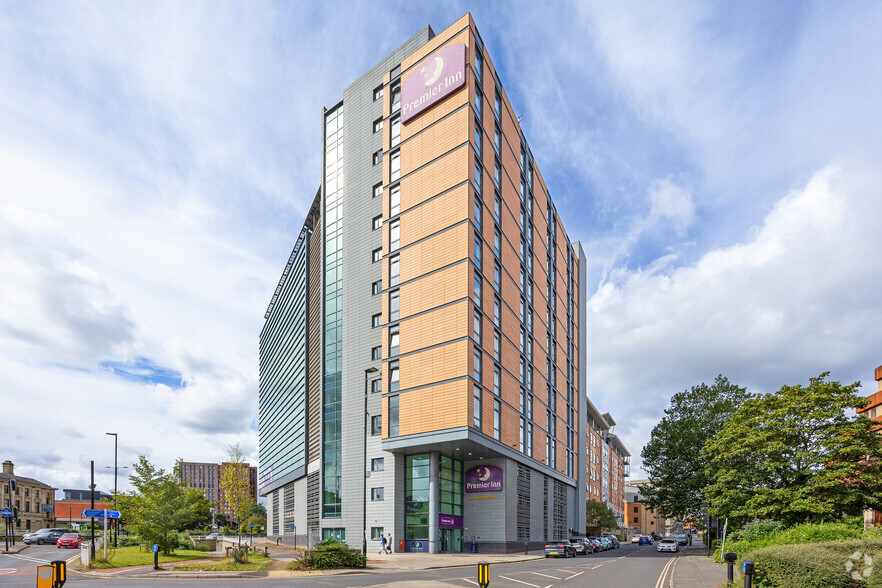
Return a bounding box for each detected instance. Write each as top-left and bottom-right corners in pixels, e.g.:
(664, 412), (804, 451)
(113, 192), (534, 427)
(738, 539), (882, 588)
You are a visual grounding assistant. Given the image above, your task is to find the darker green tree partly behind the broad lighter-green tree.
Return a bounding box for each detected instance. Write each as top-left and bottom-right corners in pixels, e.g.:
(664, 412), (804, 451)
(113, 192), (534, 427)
(640, 375), (750, 520)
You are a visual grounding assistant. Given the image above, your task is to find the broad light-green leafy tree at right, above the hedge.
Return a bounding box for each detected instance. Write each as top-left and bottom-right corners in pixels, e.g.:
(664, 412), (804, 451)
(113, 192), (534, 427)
(703, 372), (882, 525)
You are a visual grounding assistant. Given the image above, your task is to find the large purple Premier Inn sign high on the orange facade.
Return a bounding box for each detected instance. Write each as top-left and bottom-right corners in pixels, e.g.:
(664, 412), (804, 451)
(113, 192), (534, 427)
(401, 43), (465, 123)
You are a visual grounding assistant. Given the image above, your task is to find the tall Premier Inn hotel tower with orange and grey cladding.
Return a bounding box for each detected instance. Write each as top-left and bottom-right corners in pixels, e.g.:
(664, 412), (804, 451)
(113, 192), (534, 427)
(259, 15), (586, 553)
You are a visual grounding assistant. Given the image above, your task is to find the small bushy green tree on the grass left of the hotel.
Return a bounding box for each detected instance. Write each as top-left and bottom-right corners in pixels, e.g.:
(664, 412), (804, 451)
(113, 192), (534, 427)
(112, 455), (211, 555)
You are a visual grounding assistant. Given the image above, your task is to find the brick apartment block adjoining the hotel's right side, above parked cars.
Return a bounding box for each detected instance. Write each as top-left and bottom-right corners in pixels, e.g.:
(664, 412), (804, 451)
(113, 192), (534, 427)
(585, 400), (631, 525)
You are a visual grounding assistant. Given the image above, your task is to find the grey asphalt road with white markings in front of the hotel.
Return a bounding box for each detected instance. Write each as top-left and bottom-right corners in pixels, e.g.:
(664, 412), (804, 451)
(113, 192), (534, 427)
(0, 545), (678, 588)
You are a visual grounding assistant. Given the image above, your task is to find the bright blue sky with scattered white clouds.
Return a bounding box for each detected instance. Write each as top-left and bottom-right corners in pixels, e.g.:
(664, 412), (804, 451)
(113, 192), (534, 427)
(0, 0), (882, 491)
